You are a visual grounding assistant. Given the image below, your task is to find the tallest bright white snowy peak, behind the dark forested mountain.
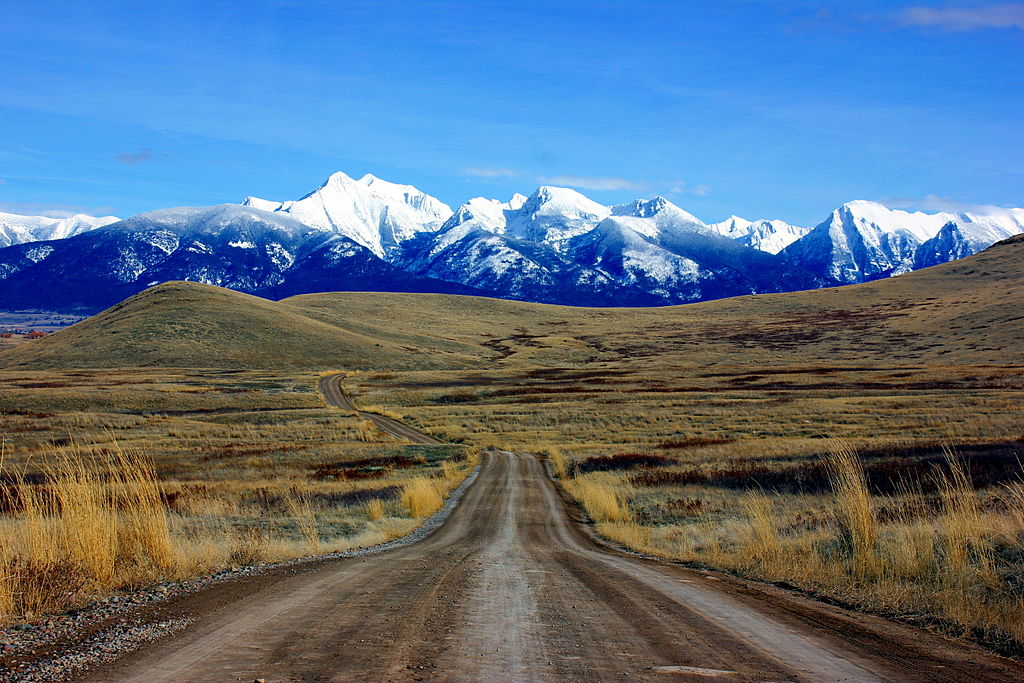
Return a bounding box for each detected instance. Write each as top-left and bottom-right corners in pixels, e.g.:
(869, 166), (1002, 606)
(243, 172), (452, 260)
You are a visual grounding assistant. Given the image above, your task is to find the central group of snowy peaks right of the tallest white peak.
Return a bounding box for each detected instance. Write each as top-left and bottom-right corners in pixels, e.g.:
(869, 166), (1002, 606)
(401, 192), (818, 305)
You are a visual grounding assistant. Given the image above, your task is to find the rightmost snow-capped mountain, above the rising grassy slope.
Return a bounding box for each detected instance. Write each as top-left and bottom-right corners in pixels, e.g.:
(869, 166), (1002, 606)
(779, 201), (1024, 285)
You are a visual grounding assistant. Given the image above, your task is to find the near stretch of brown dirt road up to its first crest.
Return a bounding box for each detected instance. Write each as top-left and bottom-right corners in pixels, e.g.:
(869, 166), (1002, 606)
(72, 376), (1024, 683)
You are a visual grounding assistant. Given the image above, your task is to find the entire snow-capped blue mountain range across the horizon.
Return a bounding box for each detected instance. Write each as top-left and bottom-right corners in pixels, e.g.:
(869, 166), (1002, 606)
(0, 173), (1024, 311)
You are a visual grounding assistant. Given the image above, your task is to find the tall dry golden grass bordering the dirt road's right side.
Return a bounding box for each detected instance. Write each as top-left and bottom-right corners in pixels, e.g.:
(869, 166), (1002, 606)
(555, 440), (1024, 655)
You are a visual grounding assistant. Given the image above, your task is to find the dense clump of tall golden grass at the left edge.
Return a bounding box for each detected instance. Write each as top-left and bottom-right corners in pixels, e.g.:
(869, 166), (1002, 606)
(0, 450), (178, 618)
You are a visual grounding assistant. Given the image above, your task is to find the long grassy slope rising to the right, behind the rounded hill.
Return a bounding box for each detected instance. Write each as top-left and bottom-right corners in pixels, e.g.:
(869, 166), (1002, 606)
(285, 238), (1024, 367)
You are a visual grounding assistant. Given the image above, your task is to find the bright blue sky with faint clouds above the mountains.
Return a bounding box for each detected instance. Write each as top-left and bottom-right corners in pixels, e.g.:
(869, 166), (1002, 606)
(0, 0), (1024, 224)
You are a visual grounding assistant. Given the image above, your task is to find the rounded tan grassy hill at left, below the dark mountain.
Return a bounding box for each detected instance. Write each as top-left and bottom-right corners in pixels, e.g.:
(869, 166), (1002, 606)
(0, 282), (483, 370)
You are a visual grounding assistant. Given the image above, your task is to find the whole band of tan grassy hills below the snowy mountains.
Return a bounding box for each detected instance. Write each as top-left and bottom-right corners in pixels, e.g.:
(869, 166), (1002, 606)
(0, 238), (1024, 370)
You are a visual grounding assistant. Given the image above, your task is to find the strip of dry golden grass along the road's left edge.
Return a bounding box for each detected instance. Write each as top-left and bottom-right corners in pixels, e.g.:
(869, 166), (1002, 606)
(0, 432), (477, 624)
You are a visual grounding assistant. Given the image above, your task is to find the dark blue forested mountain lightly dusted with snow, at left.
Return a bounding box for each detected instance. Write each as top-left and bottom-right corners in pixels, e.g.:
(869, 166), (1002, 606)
(0, 204), (473, 309)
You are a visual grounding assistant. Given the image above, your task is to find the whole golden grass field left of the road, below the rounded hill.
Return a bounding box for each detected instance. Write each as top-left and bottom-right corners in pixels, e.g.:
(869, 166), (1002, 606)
(0, 370), (475, 623)
